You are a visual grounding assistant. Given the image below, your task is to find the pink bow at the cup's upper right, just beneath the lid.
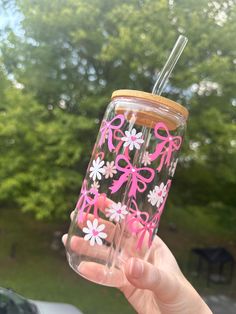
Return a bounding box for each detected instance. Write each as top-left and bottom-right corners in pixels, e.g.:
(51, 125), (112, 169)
(150, 122), (182, 171)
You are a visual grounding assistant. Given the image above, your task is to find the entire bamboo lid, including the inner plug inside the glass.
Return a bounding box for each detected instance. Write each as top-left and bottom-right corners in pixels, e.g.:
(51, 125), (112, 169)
(111, 89), (188, 130)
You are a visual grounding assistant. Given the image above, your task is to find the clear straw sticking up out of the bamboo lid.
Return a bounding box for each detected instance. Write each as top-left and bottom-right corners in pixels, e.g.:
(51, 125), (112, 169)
(152, 35), (188, 95)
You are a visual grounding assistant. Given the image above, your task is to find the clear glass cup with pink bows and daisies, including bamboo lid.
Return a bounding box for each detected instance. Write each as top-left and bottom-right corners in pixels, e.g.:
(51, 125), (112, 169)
(66, 90), (188, 287)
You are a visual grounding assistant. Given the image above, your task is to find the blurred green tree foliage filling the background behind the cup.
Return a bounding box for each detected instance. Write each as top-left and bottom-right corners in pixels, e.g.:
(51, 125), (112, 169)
(0, 0), (236, 219)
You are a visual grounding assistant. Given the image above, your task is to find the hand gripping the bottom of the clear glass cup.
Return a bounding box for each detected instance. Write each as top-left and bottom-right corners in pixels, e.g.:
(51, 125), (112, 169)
(62, 197), (212, 314)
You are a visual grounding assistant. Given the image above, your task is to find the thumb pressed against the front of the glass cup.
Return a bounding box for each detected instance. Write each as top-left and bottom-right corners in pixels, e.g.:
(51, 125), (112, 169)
(124, 257), (180, 303)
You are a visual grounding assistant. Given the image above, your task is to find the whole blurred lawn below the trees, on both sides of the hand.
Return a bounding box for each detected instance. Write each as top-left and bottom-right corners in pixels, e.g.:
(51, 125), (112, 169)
(0, 206), (236, 314)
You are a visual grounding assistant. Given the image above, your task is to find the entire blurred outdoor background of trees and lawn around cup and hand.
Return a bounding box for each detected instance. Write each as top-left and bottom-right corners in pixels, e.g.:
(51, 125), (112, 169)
(0, 0), (236, 314)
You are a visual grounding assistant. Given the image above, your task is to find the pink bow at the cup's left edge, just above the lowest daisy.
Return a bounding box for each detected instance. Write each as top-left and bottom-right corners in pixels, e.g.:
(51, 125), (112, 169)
(75, 181), (99, 222)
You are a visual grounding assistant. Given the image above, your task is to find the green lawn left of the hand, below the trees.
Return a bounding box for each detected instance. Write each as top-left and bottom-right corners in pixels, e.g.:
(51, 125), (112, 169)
(0, 210), (134, 314)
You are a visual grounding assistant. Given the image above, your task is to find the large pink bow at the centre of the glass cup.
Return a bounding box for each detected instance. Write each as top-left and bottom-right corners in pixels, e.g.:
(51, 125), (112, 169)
(110, 155), (155, 198)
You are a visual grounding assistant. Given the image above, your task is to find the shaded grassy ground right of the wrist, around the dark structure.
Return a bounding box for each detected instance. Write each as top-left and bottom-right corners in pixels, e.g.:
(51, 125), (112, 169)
(159, 206), (236, 299)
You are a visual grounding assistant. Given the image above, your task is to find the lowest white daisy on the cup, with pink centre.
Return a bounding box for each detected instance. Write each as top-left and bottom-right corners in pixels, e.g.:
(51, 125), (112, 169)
(83, 218), (107, 246)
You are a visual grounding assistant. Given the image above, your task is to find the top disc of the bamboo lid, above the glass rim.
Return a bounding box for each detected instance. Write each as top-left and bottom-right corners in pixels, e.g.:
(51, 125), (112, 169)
(111, 89), (188, 119)
